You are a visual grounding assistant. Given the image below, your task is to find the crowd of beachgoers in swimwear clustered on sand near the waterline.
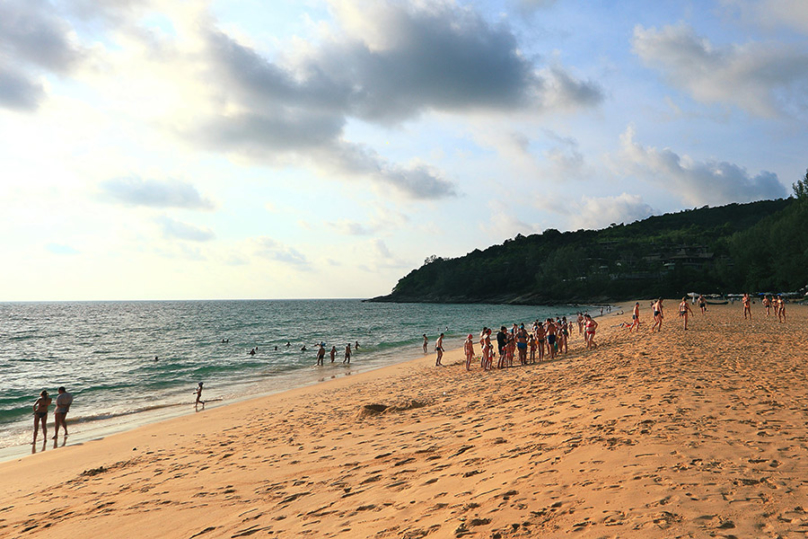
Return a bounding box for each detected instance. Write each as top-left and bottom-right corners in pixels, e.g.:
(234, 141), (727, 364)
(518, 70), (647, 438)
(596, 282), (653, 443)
(424, 313), (598, 371)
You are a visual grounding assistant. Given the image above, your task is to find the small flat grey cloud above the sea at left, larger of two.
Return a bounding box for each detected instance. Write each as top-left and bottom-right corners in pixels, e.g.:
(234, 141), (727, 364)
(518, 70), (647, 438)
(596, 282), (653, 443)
(99, 177), (215, 210)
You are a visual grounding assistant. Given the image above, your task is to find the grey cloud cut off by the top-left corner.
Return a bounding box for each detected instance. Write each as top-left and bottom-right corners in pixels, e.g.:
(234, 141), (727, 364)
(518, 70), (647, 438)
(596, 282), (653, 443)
(0, 0), (84, 111)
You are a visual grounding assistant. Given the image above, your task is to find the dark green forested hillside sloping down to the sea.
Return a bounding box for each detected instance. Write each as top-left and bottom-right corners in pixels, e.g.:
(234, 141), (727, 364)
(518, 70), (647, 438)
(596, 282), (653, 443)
(374, 191), (808, 304)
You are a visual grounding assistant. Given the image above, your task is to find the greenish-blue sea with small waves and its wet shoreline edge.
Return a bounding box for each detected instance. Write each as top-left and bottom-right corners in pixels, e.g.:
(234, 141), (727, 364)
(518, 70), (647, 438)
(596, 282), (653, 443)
(0, 300), (584, 459)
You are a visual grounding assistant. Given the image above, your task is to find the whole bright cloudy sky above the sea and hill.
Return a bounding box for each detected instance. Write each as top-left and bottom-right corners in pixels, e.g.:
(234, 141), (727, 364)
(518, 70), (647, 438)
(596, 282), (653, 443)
(0, 0), (808, 301)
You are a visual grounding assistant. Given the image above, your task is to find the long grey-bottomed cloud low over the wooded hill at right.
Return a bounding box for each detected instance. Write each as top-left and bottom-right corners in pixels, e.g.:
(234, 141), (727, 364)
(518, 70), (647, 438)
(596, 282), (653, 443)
(620, 127), (787, 205)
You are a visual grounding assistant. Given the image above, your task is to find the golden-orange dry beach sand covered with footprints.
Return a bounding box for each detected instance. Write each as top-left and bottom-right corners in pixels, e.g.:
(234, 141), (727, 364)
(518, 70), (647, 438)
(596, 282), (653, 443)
(0, 301), (808, 539)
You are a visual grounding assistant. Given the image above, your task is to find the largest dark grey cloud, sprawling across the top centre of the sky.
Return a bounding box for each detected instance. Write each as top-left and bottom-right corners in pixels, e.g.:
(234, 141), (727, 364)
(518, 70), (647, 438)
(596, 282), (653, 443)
(187, 0), (603, 199)
